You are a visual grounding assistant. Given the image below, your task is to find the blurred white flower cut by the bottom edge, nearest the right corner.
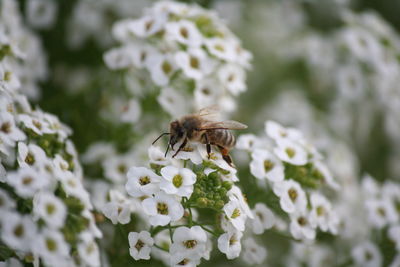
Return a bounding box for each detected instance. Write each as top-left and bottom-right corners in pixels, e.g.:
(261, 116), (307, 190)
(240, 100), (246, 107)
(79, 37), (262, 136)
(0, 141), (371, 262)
(351, 241), (382, 267)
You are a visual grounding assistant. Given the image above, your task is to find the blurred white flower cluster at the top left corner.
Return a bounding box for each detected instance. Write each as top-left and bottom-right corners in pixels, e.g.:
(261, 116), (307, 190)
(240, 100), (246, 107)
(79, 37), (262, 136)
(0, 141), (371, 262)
(0, 0), (47, 99)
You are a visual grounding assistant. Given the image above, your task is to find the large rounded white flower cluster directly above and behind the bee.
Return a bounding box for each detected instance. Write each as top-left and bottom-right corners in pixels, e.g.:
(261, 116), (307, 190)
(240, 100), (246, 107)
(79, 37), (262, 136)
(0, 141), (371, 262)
(104, 1), (251, 116)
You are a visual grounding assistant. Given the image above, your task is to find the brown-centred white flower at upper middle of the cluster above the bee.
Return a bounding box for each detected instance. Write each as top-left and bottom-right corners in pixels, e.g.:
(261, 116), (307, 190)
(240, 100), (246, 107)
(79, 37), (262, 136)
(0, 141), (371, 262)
(165, 20), (203, 47)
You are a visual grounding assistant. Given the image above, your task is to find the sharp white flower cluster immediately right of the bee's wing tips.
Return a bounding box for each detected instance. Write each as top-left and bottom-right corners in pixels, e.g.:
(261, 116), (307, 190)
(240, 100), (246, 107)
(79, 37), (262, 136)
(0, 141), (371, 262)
(237, 121), (339, 240)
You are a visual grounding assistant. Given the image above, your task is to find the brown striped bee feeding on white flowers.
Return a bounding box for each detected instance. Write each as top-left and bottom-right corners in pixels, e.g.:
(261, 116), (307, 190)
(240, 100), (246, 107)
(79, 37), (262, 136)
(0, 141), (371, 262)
(153, 106), (247, 166)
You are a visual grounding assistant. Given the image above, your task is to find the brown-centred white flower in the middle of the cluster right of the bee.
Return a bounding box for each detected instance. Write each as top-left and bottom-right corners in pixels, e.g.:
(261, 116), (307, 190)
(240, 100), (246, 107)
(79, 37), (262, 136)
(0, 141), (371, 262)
(273, 180), (307, 216)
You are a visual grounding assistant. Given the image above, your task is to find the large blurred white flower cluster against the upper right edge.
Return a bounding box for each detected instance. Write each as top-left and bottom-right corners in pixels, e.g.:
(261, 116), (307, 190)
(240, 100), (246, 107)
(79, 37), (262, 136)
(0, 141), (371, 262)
(289, 10), (400, 147)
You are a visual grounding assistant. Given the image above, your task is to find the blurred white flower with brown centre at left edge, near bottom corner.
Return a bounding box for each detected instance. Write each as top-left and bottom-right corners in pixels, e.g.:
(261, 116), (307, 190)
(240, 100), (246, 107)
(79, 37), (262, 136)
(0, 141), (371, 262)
(0, 211), (36, 252)
